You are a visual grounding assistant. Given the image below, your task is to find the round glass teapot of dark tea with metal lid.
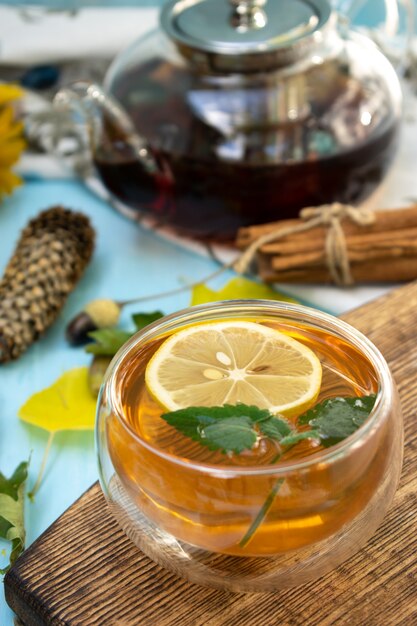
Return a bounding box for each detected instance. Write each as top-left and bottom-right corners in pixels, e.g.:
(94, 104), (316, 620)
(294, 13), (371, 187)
(56, 0), (410, 240)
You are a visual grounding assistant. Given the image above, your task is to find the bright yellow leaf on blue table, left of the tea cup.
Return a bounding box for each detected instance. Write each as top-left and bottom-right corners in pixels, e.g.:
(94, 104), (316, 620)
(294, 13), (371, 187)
(19, 367), (96, 432)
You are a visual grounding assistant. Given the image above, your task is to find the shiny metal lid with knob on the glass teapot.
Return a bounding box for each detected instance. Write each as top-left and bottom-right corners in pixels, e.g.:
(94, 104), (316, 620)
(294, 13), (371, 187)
(160, 0), (332, 72)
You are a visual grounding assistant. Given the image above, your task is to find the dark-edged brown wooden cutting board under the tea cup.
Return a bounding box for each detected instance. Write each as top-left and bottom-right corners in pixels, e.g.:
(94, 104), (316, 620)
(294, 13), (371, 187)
(4, 283), (417, 626)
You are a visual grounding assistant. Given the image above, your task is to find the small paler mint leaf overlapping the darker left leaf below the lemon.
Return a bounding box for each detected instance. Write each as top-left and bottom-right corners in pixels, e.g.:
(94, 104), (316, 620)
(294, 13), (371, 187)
(200, 417), (257, 454)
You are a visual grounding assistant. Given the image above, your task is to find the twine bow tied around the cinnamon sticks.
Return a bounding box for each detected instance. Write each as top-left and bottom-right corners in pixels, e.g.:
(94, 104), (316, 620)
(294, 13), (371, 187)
(233, 202), (375, 285)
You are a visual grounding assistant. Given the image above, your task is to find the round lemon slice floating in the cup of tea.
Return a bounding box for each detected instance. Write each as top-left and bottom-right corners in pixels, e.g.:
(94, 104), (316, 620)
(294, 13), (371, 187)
(145, 320), (321, 417)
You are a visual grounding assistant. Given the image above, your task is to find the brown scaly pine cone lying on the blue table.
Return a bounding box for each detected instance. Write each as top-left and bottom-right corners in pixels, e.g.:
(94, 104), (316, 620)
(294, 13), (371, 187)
(0, 206), (95, 363)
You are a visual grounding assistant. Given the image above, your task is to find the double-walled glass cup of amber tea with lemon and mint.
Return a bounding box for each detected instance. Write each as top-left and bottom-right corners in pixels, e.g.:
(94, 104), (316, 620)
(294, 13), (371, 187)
(96, 300), (403, 591)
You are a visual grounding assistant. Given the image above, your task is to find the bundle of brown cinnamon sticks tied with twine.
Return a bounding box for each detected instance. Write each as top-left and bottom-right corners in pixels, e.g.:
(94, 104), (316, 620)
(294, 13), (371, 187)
(236, 204), (417, 283)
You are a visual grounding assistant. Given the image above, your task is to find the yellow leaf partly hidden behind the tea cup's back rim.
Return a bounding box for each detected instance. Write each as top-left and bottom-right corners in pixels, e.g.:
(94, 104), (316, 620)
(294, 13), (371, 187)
(191, 276), (297, 306)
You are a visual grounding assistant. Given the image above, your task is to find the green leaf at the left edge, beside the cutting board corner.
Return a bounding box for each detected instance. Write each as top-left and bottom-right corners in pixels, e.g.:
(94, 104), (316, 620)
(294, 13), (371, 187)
(0, 461), (29, 574)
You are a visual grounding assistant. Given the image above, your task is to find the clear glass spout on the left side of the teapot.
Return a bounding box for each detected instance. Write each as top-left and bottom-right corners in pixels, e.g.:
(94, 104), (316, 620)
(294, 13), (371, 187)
(54, 81), (162, 218)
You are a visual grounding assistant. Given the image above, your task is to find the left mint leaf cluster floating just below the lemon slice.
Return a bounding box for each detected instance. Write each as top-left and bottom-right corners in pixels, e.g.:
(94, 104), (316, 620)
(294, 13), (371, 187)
(161, 404), (271, 453)
